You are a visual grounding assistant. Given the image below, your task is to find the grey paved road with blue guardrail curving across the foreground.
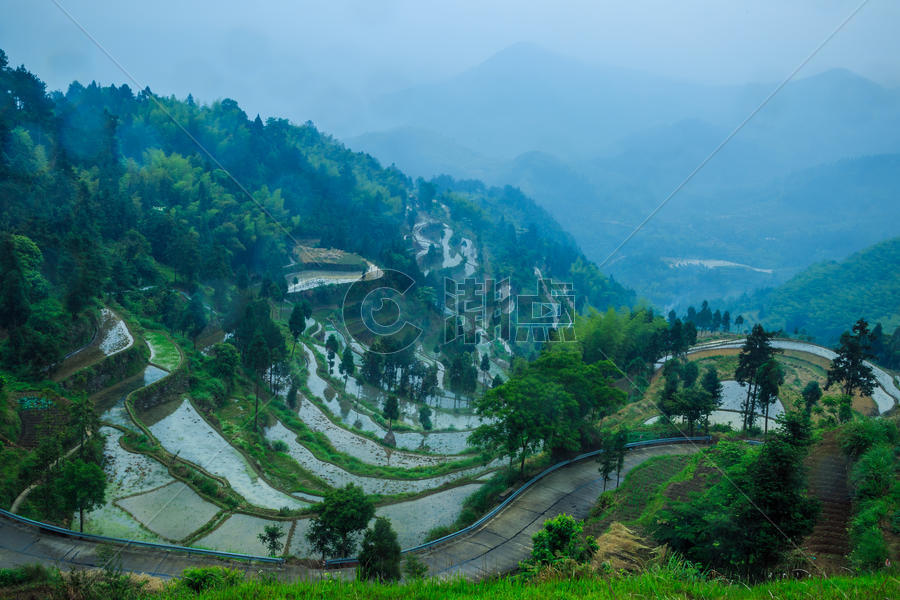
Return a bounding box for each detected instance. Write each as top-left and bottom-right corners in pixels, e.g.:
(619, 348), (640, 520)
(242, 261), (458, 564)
(0, 444), (696, 579)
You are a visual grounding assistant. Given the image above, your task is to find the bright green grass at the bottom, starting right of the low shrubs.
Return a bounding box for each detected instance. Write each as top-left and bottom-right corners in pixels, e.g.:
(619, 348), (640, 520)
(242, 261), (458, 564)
(158, 572), (900, 600)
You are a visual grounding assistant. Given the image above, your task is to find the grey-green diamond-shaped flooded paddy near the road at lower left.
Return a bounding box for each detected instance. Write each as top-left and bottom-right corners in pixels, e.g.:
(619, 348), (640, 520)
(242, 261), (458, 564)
(116, 481), (219, 542)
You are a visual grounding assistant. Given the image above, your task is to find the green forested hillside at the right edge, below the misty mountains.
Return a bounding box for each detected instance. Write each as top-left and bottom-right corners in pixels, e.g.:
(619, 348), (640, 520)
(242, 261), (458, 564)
(748, 238), (900, 343)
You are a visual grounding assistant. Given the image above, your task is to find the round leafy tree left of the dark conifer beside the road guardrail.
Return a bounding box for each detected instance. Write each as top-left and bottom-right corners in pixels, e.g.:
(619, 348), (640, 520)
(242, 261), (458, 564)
(306, 483), (375, 560)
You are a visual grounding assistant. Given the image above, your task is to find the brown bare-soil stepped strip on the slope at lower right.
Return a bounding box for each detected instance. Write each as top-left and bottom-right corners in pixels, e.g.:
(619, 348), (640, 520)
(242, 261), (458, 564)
(803, 431), (852, 573)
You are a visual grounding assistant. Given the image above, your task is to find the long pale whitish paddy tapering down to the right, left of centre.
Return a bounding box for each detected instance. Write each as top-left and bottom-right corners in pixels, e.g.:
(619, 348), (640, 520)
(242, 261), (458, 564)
(149, 399), (320, 510)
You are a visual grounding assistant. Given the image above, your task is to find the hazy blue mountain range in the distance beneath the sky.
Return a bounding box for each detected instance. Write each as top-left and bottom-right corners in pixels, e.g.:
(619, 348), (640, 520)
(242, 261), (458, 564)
(347, 44), (900, 306)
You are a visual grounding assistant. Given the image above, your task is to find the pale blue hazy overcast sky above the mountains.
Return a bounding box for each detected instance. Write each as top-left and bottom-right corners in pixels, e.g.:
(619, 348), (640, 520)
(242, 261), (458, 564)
(0, 0), (900, 133)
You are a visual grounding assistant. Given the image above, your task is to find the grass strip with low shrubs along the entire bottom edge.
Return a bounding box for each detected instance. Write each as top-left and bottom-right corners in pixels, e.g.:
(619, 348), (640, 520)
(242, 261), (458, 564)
(0, 565), (900, 600)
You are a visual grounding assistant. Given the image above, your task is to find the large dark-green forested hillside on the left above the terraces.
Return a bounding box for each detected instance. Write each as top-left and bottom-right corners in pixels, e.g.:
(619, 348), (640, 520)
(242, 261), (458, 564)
(0, 47), (634, 374)
